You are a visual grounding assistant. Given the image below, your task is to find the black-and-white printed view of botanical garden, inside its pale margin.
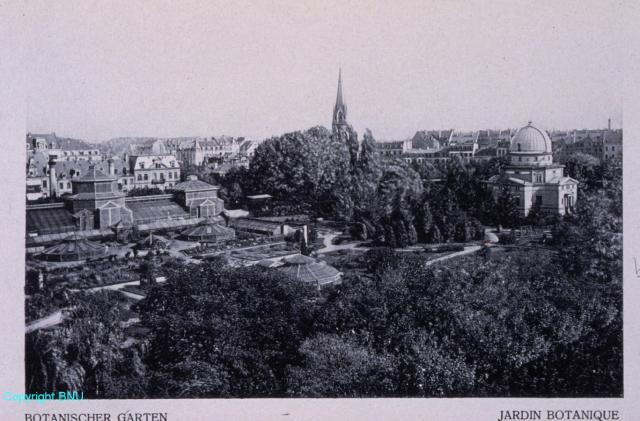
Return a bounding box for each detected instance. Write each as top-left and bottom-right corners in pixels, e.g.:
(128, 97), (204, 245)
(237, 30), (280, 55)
(1, 0), (640, 420)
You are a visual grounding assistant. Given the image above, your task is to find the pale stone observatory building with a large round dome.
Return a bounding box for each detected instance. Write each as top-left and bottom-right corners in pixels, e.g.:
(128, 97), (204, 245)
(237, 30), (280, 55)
(488, 122), (578, 213)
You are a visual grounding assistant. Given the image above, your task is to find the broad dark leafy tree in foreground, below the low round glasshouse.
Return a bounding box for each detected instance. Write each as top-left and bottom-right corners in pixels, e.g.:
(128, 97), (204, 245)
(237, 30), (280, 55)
(139, 261), (316, 397)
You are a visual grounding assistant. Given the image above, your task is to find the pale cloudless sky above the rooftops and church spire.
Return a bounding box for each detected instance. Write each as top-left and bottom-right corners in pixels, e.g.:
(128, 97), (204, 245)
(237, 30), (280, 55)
(24, 0), (626, 141)
